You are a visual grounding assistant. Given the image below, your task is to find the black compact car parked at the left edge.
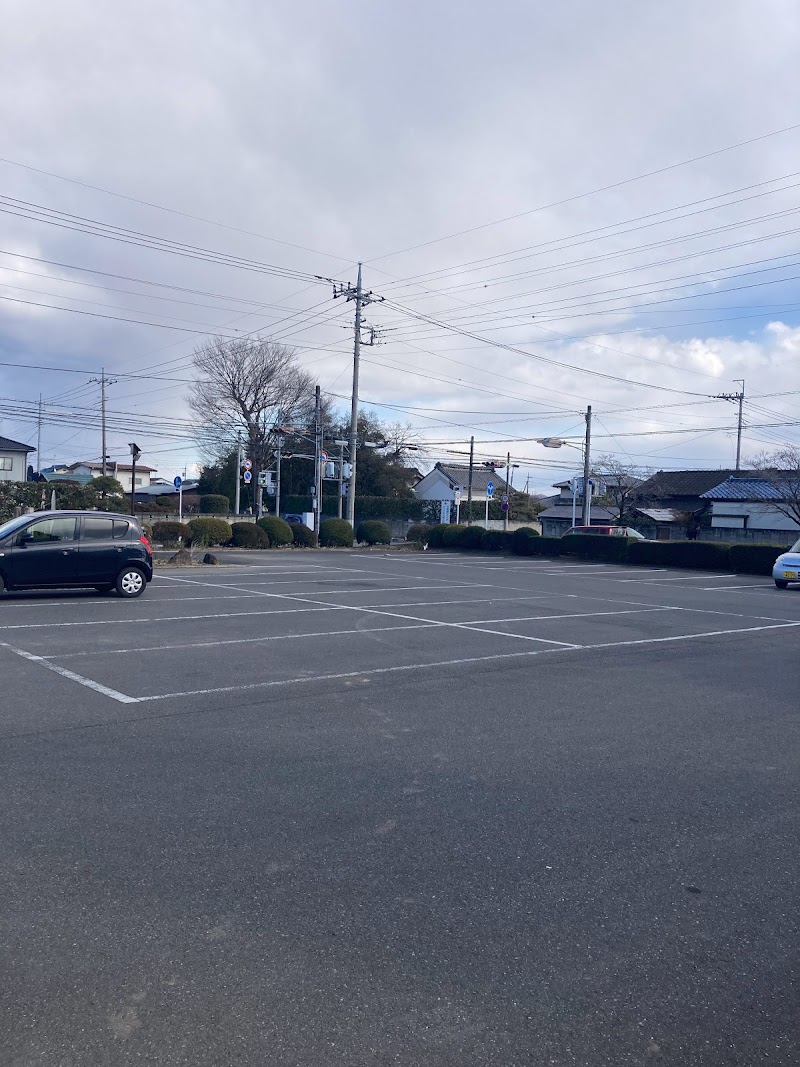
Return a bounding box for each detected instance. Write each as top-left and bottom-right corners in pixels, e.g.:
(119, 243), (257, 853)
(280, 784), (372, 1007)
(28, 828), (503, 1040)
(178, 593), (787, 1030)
(0, 511), (153, 596)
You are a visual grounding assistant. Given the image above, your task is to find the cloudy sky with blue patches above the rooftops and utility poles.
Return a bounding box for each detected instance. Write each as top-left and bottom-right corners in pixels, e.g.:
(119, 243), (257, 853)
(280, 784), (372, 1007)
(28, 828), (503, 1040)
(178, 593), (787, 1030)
(0, 0), (800, 488)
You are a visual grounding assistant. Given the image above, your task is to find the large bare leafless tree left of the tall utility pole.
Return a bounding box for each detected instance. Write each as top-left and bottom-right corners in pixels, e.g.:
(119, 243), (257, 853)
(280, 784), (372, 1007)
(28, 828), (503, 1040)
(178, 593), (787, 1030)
(189, 337), (315, 503)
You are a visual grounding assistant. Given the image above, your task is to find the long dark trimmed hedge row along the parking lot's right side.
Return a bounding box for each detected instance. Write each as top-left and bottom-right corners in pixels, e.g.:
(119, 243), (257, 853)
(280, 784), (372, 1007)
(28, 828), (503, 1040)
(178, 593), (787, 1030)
(416, 525), (786, 574)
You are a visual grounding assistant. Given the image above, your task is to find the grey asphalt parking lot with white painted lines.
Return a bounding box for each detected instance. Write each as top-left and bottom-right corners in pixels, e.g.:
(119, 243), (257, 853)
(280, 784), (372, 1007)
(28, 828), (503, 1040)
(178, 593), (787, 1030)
(0, 551), (800, 1067)
